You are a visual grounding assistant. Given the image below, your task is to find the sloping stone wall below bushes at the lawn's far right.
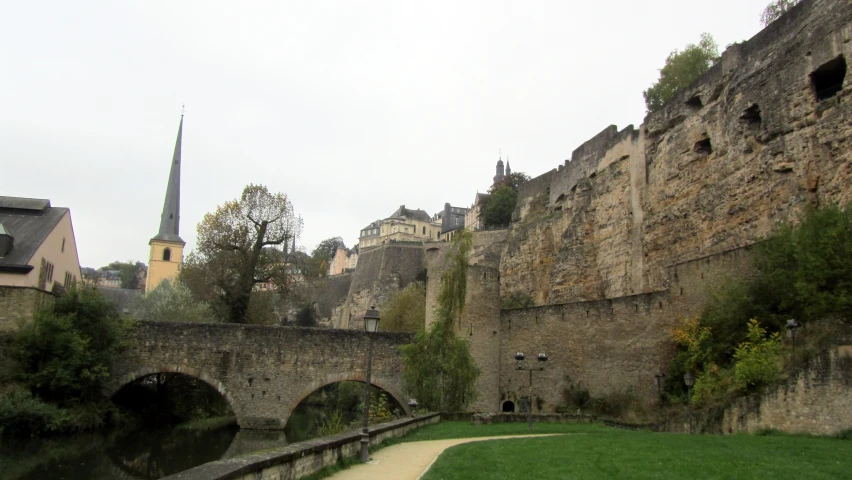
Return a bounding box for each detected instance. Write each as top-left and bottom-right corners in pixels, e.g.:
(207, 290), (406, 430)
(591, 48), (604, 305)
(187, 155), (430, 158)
(722, 345), (852, 435)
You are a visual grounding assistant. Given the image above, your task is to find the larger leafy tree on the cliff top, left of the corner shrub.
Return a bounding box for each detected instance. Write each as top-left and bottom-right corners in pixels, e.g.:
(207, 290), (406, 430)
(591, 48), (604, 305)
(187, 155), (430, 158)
(642, 33), (719, 113)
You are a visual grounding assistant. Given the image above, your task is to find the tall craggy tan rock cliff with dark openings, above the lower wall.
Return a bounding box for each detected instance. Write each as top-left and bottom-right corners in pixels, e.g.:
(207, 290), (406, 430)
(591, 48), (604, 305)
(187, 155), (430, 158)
(500, 0), (852, 305)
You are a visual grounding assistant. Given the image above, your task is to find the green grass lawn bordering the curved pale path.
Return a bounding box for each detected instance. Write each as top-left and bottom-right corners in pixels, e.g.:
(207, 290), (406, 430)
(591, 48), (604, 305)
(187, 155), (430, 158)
(420, 422), (852, 480)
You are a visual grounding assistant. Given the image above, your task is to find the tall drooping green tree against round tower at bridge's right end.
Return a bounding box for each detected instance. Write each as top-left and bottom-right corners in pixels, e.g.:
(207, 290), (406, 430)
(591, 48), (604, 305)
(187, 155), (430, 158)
(401, 231), (479, 412)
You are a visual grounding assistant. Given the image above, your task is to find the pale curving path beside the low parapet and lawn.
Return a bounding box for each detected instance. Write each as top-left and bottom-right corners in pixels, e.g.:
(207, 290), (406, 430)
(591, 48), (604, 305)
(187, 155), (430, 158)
(329, 433), (561, 480)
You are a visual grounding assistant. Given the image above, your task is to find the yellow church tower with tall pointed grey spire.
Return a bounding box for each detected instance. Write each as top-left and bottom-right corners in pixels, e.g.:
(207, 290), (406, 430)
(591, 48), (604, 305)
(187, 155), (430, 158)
(145, 114), (186, 292)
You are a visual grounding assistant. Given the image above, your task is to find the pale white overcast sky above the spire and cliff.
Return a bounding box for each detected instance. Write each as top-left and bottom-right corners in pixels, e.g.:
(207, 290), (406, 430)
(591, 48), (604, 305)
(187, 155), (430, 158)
(0, 0), (768, 267)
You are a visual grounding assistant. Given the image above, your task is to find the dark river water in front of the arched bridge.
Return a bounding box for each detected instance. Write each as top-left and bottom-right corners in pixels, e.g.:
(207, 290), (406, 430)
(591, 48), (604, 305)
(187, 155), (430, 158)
(0, 405), (350, 480)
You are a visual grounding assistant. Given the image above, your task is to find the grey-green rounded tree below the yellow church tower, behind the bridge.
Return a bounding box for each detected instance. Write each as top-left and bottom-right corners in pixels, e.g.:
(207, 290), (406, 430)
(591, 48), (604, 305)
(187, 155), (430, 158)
(133, 280), (218, 323)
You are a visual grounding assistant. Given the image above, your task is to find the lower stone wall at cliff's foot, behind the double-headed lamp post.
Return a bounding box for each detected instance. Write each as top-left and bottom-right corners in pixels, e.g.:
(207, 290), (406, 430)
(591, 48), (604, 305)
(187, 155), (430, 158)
(496, 244), (751, 412)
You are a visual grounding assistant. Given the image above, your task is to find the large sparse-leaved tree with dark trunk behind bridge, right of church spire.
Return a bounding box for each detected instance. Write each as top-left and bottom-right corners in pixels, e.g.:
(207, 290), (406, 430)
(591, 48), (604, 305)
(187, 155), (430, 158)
(181, 185), (302, 323)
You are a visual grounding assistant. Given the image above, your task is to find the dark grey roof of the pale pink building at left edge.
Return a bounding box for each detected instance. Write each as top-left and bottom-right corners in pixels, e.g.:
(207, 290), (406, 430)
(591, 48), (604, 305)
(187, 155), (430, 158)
(0, 197), (68, 273)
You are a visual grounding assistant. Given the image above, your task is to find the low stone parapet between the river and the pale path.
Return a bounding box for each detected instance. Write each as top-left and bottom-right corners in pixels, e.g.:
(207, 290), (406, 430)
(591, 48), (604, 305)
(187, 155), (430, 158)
(164, 413), (441, 480)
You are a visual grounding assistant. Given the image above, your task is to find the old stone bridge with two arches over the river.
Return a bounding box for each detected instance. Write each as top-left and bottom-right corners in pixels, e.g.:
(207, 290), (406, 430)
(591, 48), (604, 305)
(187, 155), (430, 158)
(105, 322), (412, 429)
